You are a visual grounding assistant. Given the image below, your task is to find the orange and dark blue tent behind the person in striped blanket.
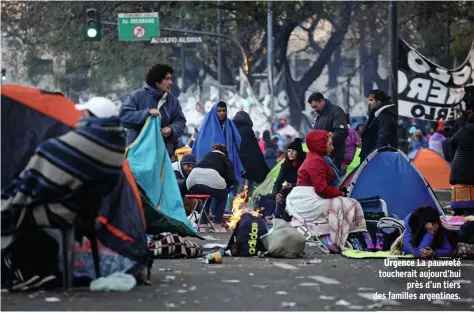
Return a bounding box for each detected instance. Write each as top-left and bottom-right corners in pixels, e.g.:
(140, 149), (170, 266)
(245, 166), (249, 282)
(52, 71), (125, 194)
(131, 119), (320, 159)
(1, 85), (148, 278)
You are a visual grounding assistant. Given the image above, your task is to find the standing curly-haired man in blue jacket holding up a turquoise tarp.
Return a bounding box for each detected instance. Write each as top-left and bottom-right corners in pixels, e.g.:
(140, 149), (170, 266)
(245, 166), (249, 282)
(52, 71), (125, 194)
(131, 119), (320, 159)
(119, 64), (186, 156)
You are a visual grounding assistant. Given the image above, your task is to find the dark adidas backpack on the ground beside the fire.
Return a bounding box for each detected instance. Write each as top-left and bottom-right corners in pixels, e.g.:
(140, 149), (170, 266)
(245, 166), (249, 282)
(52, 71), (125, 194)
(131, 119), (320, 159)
(225, 213), (267, 256)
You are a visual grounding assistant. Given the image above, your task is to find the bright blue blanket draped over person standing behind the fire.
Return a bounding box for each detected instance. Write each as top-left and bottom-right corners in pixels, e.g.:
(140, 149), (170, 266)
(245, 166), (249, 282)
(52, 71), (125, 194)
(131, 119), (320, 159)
(192, 104), (244, 181)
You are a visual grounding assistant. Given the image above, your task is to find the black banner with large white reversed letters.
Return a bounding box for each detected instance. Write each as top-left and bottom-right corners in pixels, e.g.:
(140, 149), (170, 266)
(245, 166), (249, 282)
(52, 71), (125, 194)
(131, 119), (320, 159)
(398, 39), (474, 121)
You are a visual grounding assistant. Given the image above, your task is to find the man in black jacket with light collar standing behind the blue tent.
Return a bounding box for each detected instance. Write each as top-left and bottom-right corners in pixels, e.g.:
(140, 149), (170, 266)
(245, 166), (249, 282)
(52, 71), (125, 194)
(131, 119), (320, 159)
(360, 89), (398, 162)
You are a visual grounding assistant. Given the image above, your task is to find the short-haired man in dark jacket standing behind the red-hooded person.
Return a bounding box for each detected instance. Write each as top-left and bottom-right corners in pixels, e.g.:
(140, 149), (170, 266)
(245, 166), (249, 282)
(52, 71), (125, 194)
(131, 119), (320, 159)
(308, 93), (349, 170)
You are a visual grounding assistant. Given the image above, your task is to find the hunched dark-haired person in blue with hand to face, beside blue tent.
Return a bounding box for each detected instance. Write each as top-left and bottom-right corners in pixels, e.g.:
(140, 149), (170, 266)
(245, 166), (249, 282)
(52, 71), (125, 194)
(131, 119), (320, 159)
(403, 206), (453, 258)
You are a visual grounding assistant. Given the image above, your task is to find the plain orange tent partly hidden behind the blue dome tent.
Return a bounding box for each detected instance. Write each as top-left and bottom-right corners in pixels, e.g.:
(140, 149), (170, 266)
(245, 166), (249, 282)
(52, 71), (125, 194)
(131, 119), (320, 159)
(413, 148), (451, 190)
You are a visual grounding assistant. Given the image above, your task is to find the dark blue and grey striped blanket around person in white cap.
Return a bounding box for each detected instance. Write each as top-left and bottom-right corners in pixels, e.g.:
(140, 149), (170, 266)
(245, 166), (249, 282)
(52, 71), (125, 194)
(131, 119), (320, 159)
(1, 117), (125, 249)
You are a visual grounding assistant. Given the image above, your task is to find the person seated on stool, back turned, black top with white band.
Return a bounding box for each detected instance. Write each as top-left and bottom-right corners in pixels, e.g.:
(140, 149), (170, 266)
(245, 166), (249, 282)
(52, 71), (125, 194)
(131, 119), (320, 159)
(186, 144), (237, 232)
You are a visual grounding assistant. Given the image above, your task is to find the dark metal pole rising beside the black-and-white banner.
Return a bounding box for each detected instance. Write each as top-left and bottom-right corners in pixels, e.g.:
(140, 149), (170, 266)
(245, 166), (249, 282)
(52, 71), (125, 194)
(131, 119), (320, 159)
(389, 0), (398, 113)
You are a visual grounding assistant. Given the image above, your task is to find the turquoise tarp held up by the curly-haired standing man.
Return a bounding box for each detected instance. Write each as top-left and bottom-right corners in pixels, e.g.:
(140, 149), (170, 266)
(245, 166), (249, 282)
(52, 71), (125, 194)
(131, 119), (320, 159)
(126, 117), (197, 236)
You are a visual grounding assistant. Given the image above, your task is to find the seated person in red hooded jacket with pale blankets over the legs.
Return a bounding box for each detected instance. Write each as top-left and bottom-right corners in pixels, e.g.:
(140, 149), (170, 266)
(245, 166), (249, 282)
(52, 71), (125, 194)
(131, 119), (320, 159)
(286, 130), (367, 249)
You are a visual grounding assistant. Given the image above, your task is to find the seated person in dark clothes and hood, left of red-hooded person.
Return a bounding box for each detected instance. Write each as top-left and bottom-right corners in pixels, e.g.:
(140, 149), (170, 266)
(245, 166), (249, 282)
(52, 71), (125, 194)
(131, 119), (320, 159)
(272, 138), (306, 220)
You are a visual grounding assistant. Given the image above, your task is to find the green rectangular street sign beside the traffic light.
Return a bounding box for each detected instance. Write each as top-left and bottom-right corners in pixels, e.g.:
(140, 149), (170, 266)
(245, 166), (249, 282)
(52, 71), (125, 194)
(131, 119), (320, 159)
(118, 12), (160, 41)
